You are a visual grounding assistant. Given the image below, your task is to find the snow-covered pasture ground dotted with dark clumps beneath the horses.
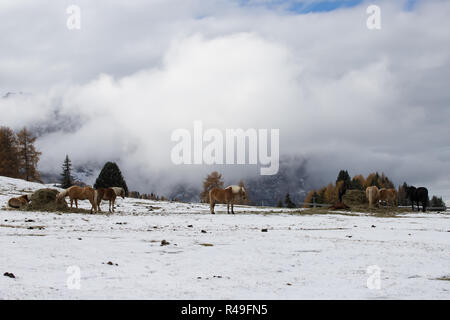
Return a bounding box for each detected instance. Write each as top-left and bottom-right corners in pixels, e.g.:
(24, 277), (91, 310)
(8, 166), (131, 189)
(0, 177), (450, 299)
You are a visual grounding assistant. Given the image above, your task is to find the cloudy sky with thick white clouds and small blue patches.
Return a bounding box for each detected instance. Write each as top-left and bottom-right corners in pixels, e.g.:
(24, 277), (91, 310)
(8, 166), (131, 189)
(0, 0), (450, 200)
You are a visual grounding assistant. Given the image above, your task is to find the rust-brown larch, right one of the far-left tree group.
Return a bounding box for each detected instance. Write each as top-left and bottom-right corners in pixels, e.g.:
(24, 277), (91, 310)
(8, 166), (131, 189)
(17, 128), (42, 181)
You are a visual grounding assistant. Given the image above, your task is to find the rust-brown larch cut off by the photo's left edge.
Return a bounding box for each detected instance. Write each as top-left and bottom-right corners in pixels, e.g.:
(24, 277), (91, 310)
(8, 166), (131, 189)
(0, 127), (20, 178)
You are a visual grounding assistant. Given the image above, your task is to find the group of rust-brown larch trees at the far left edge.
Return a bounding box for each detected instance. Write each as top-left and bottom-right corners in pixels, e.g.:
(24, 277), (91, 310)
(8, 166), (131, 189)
(0, 127), (41, 182)
